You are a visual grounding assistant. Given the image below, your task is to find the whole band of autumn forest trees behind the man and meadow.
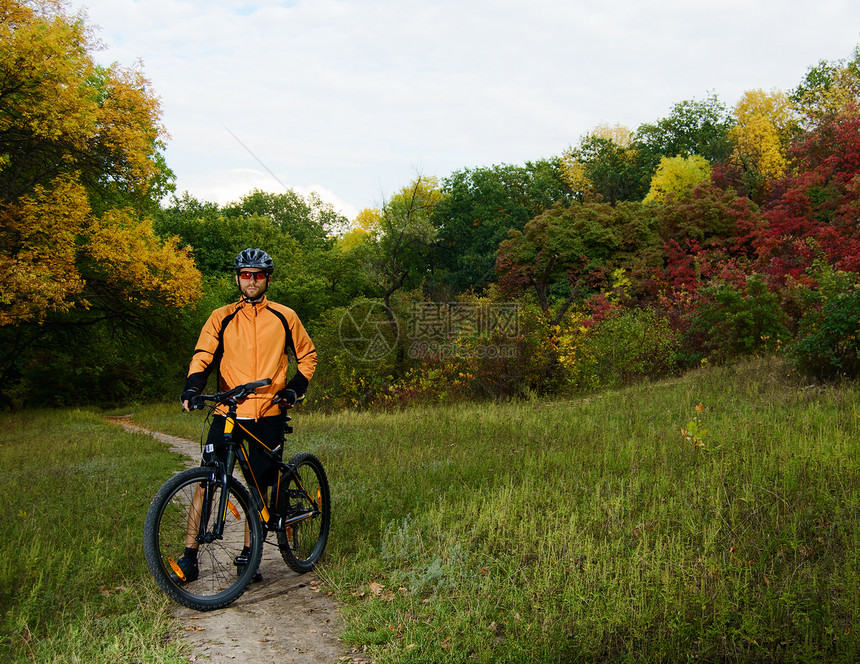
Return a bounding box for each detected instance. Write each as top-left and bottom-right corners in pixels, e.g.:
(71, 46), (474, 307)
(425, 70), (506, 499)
(0, 0), (860, 409)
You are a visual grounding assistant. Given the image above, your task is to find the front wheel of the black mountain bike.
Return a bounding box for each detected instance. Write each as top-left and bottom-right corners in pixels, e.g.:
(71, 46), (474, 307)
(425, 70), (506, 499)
(143, 468), (263, 611)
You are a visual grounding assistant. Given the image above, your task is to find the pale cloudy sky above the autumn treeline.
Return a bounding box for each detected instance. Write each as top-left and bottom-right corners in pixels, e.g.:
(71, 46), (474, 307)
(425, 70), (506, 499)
(68, 0), (860, 219)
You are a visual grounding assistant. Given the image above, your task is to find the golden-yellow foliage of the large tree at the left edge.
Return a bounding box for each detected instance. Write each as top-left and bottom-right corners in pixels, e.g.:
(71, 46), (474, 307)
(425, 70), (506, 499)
(0, 0), (199, 326)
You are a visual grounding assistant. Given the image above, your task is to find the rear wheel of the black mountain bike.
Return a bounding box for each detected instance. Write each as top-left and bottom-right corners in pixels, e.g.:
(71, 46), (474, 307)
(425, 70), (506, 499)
(276, 452), (331, 574)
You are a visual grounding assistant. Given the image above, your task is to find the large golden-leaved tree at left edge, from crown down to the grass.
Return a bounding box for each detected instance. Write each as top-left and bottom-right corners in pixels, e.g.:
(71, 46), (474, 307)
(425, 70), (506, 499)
(0, 0), (200, 403)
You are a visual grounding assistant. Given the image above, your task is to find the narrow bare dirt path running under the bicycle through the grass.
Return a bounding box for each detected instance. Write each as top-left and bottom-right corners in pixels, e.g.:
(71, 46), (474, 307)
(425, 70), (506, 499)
(109, 417), (369, 664)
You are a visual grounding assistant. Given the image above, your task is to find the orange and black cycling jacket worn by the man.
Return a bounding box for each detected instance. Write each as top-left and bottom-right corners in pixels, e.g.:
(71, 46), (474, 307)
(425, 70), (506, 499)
(185, 296), (317, 419)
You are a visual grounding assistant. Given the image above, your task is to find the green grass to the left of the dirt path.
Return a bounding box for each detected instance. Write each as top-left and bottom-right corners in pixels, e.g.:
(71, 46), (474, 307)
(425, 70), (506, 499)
(0, 410), (185, 664)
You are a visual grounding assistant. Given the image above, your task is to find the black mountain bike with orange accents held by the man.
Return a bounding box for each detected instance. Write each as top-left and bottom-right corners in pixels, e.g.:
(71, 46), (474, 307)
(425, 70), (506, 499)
(143, 378), (331, 611)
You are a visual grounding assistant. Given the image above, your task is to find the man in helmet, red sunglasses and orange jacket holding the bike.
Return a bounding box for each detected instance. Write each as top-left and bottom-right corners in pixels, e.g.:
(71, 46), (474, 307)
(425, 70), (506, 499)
(174, 248), (317, 582)
